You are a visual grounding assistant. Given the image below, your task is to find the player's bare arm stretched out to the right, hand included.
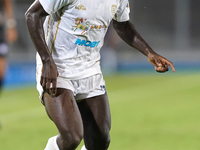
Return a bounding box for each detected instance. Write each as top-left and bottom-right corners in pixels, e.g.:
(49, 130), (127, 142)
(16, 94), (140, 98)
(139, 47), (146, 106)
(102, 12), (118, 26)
(113, 20), (175, 72)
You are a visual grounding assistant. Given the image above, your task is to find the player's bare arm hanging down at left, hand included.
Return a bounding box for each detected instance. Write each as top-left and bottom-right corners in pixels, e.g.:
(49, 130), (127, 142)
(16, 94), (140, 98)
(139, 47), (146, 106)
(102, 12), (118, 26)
(25, 0), (58, 95)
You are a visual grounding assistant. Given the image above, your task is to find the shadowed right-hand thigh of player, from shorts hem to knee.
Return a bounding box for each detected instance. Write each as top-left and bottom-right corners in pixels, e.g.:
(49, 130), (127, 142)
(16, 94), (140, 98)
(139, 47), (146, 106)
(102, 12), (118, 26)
(78, 94), (111, 138)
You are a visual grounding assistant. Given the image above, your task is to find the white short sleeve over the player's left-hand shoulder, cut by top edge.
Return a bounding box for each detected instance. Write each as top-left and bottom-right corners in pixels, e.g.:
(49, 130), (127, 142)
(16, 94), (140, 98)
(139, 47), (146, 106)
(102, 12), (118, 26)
(39, 0), (77, 14)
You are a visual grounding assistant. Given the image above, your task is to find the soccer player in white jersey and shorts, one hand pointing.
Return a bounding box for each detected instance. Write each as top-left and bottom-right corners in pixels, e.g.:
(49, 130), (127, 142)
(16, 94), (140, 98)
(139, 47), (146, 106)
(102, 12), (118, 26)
(25, 0), (175, 150)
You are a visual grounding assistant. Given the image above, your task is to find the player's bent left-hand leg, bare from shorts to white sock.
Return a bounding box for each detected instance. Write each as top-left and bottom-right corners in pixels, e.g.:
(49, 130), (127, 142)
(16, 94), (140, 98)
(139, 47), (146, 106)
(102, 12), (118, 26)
(43, 89), (83, 150)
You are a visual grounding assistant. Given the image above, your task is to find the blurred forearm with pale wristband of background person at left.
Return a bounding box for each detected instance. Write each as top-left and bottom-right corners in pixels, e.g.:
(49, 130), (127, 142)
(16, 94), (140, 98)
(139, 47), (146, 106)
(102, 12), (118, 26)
(3, 0), (18, 43)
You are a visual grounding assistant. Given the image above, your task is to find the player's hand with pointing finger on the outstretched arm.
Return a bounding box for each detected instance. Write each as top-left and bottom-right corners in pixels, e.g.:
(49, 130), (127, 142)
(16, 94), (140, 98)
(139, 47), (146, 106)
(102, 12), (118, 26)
(148, 53), (175, 73)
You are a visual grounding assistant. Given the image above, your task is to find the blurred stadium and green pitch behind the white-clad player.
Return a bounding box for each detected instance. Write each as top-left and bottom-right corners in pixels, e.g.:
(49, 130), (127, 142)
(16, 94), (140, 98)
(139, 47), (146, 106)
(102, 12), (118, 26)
(0, 0), (200, 150)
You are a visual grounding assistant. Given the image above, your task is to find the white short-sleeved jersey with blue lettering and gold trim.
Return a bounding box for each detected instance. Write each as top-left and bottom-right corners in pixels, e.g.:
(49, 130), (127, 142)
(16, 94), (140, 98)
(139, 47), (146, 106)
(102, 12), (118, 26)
(37, 0), (130, 80)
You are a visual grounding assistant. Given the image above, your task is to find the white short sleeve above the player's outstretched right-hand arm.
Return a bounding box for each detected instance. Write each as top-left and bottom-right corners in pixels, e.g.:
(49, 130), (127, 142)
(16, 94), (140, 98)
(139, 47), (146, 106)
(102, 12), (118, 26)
(113, 0), (130, 22)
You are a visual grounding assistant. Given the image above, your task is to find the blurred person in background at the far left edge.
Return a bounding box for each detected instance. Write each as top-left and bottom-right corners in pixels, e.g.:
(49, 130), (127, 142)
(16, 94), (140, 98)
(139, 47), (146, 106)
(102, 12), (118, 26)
(0, 0), (17, 89)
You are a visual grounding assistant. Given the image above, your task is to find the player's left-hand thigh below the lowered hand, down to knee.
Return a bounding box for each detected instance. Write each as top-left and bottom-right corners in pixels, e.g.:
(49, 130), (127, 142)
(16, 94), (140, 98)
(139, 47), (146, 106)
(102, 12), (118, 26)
(43, 89), (83, 133)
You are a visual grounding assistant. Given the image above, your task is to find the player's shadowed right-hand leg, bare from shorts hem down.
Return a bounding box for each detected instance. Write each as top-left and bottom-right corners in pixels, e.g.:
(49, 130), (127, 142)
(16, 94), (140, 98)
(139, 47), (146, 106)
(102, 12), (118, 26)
(78, 94), (111, 150)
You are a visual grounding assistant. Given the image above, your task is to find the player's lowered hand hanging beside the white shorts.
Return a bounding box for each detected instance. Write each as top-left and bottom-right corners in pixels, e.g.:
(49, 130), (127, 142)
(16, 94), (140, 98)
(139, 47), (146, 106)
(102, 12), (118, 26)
(40, 61), (58, 96)
